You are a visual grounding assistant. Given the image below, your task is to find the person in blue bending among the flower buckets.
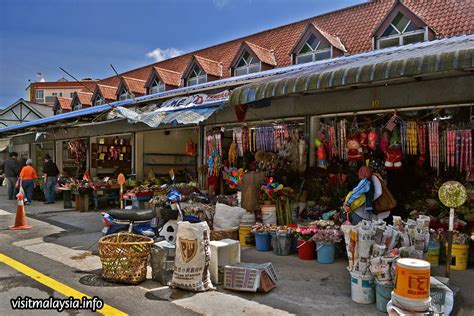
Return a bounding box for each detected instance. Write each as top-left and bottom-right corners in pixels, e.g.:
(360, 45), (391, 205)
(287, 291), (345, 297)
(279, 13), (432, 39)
(342, 166), (382, 225)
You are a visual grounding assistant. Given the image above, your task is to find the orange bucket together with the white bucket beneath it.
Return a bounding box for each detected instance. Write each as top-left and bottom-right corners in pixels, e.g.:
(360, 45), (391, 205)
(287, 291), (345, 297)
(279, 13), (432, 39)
(391, 258), (431, 312)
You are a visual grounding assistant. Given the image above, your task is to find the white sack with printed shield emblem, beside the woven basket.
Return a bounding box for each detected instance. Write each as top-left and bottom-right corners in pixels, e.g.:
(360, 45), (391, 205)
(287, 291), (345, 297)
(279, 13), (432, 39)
(170, 222), (214, 292)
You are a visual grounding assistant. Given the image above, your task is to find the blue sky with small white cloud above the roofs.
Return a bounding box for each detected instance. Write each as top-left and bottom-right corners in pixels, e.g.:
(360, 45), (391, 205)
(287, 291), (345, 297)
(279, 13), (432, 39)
(0, 0), (364, 107)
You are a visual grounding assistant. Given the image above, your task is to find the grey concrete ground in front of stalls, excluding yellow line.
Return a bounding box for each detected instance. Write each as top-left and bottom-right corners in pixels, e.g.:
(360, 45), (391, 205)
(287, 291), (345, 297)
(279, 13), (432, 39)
(0, 188), (474, 315)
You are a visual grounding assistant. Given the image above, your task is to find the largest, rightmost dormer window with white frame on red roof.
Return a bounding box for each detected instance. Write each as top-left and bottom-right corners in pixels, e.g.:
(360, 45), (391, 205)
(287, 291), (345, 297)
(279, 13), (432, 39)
(377, 12), (426, 48)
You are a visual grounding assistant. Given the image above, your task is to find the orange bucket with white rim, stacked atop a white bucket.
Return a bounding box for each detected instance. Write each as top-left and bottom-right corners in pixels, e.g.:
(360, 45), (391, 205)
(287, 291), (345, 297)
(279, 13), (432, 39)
(394, 258), (431, 300)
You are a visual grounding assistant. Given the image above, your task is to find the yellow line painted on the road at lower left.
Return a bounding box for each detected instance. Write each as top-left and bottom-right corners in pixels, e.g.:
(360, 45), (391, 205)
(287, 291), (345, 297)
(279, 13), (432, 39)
(0, 253), (128, 316)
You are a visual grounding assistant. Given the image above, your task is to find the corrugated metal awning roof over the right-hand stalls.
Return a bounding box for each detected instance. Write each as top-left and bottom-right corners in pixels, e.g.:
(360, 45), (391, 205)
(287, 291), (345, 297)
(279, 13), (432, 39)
(230, 35), (474, 105)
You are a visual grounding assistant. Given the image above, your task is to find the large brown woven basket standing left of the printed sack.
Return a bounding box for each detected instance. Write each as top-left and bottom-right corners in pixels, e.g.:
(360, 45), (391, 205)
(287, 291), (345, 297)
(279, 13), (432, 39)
(99, 233), (153, 284)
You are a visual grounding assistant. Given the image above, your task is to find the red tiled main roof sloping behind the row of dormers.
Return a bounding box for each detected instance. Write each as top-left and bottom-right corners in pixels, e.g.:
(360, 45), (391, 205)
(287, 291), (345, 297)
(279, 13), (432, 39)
(95, 0), (474, 86)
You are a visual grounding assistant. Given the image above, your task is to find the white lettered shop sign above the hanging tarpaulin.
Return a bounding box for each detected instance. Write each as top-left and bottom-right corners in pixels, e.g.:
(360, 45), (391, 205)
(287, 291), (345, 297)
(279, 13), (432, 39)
(158, 90), (230, 112)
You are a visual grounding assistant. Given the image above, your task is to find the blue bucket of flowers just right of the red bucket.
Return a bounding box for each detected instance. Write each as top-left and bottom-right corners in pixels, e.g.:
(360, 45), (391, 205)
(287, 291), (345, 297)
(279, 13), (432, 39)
(311, 226), (342, 263)
